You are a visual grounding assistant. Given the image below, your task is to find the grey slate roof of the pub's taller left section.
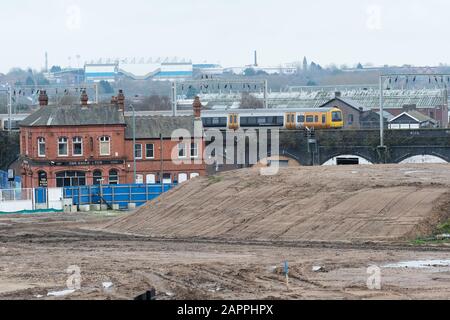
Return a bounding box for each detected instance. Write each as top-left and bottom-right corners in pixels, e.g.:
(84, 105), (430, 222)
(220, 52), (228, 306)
(20, 105), (125, 127)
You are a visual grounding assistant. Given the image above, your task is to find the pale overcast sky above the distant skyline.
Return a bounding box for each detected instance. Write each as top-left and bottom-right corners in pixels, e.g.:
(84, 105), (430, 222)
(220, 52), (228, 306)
(0, 0), (450, 72)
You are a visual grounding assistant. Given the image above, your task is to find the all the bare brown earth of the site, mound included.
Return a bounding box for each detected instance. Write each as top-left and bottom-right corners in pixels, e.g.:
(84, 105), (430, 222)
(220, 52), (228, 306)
(0, 164), (450, 300)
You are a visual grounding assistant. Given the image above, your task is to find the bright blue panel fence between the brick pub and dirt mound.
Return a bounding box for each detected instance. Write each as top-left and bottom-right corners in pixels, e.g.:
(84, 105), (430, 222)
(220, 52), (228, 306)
(61, 184), (176, 209)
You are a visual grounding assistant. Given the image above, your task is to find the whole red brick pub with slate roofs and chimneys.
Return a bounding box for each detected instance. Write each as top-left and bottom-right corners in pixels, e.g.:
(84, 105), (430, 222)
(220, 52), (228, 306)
(20, 91), (206, 188)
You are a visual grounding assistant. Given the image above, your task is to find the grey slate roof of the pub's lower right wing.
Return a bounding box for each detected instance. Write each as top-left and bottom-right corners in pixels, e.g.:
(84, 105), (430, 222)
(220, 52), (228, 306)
(125, 116), (195, 139)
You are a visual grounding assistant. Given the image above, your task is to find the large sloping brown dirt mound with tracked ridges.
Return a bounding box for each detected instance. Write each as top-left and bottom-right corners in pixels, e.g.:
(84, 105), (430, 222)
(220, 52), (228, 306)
(103, 165), (450, 241)
